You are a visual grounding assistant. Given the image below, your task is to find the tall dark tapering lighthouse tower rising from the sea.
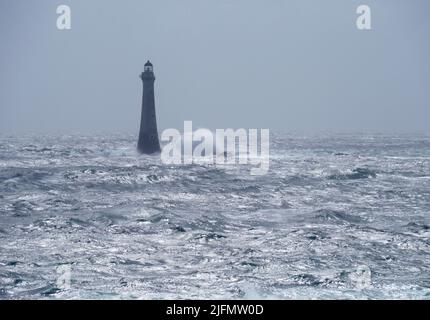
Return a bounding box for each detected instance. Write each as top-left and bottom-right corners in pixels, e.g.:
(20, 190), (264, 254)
(137, 60), (160, 154)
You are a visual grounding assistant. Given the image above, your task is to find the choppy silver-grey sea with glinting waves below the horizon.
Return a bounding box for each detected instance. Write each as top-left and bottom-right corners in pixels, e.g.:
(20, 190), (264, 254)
(0, 133), (430, 299)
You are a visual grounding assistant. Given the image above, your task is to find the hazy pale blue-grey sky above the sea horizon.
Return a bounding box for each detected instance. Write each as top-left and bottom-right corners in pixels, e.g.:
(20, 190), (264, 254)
(0, 0), (430, 133)
